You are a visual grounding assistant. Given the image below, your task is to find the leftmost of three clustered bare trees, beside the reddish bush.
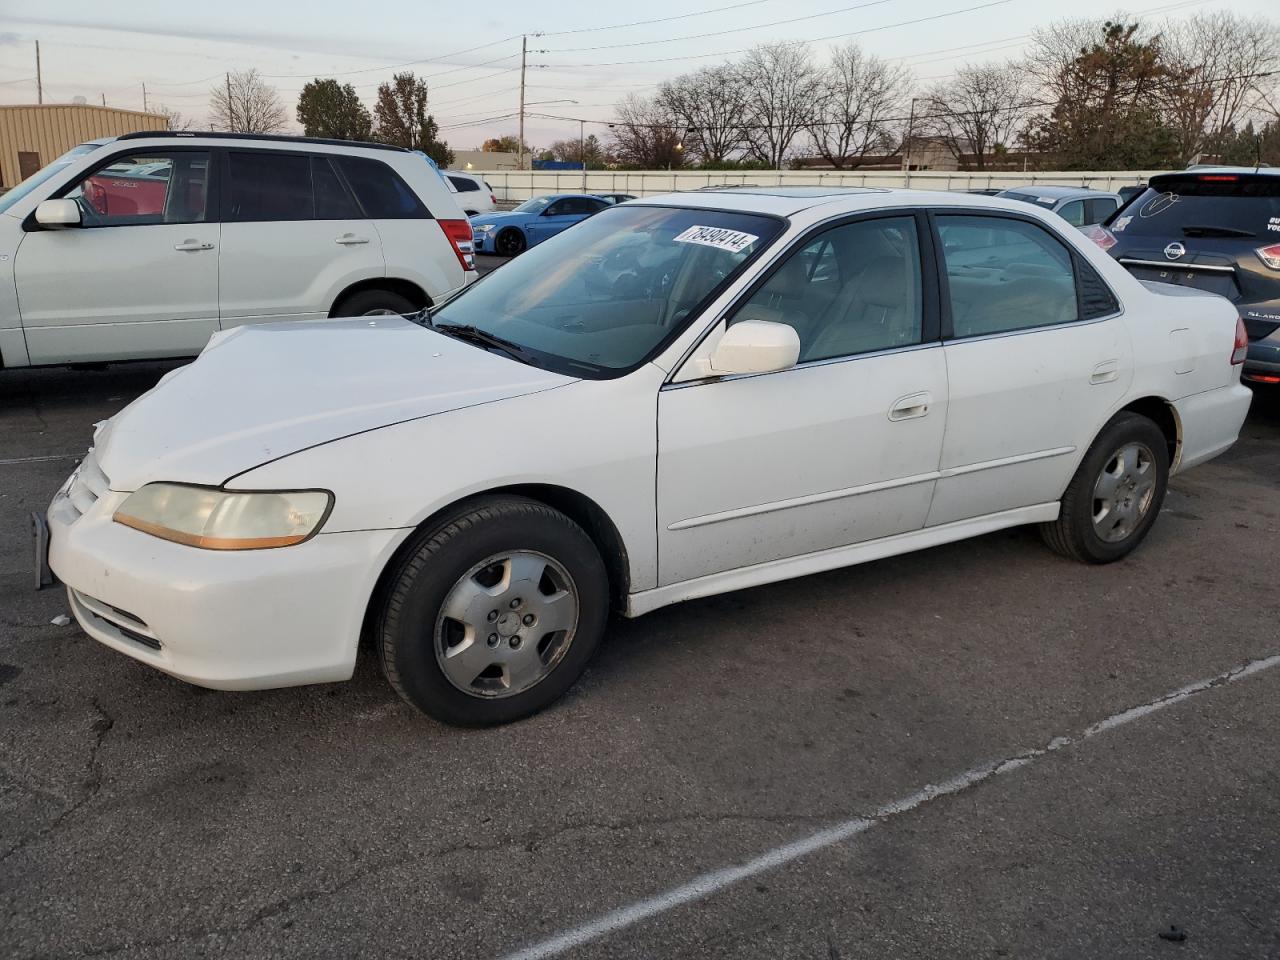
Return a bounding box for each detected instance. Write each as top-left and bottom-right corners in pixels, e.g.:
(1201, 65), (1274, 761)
(657, 64), (748, 164)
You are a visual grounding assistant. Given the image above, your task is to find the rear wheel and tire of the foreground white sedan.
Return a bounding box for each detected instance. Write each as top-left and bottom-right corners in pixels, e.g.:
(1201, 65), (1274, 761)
(1041, 411), (1169, 563)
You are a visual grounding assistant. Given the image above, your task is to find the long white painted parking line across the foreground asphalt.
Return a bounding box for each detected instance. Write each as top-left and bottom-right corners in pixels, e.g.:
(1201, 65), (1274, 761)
(502, 654), (1280, 960)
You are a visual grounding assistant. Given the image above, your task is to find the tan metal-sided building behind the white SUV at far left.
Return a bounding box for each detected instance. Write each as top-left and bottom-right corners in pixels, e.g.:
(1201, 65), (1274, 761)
(0, 104), (169, 189)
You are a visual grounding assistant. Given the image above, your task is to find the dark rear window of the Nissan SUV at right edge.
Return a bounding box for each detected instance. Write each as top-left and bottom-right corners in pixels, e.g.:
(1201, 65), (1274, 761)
(1107, 174), (1280, 239)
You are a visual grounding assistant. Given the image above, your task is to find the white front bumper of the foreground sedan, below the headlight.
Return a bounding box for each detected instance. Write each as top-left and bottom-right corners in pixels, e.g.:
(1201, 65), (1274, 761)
(47, 490), (408, 690)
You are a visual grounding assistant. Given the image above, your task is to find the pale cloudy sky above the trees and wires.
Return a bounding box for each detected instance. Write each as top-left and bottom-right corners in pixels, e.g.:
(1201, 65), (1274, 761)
(0, 0), (1277, 150)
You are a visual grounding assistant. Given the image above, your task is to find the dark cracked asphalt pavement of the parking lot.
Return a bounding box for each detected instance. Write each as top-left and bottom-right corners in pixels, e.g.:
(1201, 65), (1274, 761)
(0, 364), (1280, 960)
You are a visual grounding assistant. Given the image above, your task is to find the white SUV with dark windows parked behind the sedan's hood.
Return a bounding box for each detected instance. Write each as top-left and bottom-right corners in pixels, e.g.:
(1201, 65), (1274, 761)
(0, 132), (476, 367)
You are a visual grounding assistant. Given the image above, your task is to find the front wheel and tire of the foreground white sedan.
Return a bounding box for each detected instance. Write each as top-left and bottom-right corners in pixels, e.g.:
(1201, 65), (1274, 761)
(375, 497), (609, 727)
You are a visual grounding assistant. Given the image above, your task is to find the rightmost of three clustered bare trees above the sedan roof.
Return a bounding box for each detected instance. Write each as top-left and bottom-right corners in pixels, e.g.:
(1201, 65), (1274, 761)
(808, 44), (913, 170)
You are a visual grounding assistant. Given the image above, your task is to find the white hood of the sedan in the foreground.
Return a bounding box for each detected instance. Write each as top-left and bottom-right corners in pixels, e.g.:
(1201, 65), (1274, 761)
(95, 316), (573, 492)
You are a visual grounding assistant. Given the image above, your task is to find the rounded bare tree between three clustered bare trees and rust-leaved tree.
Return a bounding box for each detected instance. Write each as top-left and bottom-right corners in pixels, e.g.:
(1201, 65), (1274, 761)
(908, 64), (1030, 170)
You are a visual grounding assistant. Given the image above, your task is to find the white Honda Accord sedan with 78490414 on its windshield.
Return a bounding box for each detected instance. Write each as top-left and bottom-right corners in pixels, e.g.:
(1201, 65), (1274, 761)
(47, 187), (1249, 724)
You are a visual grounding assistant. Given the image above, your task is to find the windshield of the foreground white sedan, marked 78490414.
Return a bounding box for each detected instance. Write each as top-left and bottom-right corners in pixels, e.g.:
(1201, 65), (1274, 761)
(431, 206), (783, 378)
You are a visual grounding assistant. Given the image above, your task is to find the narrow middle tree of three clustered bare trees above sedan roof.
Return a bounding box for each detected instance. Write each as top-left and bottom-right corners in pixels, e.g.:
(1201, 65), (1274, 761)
(739, 42), (819, 170)
